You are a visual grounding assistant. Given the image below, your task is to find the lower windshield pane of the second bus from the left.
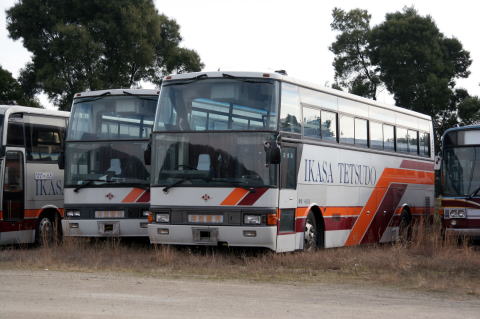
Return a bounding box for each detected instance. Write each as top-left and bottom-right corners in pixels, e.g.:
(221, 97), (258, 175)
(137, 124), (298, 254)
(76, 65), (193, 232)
(65, 141), (150, 186)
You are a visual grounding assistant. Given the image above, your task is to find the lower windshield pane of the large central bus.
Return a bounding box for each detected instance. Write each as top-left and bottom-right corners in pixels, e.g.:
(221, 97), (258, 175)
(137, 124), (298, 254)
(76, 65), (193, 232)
(152, 132), (278, 187)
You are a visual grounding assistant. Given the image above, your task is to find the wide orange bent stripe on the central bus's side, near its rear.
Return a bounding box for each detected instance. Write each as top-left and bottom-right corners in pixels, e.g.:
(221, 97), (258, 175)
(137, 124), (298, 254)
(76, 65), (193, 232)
(345, 168), (434, 246)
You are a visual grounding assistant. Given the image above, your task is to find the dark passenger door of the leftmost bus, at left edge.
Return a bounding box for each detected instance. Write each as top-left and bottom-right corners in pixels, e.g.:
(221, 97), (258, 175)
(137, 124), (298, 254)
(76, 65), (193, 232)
(0, 151), (26, 244)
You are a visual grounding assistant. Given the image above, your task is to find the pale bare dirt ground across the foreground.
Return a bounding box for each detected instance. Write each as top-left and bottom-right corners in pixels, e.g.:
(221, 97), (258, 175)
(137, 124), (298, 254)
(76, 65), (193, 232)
(0, 270), (480, 319)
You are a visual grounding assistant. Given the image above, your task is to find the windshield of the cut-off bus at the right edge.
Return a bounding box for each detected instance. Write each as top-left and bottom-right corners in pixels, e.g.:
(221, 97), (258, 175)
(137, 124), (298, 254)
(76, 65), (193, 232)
(441, 146), (480, 196)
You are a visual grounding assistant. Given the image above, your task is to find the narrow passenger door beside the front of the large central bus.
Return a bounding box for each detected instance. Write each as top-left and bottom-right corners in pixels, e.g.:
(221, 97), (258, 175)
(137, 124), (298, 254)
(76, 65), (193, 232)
(277, 144), (303, 252)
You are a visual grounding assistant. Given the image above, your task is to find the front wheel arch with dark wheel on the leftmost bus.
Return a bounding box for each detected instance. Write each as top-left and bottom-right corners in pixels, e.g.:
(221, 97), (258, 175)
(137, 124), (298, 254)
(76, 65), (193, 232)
(35, 208), (62, 246)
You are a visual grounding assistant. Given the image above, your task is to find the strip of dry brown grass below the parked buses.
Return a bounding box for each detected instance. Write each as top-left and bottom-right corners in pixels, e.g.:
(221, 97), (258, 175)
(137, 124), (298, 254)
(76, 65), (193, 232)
(0, 220), (480, 296)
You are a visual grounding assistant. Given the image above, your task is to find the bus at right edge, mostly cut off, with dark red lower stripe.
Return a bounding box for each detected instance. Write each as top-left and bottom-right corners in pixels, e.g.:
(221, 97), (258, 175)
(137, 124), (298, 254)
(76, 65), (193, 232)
(438, 125), (480, 238)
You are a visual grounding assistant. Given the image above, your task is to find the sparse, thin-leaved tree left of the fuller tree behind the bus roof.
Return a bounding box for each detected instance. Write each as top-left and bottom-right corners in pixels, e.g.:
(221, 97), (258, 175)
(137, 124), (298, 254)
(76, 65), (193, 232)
(329, 8), (381, 100)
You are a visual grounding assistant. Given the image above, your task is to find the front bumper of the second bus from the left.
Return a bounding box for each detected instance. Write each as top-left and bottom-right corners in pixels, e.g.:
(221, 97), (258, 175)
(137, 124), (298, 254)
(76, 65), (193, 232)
(62, 218), (148, 237)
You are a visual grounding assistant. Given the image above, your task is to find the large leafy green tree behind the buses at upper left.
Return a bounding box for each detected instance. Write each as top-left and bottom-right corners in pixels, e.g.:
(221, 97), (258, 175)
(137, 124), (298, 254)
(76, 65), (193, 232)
(7, 0), (203, 110)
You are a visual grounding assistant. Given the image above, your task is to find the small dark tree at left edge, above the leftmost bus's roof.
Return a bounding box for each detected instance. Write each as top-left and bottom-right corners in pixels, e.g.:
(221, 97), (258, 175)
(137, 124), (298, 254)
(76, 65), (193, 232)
(0, 67), (41, 107)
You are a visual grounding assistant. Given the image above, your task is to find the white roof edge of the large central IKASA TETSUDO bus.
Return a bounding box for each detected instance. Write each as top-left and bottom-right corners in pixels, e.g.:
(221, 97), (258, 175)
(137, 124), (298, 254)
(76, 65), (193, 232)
(163, 71), (431, 121)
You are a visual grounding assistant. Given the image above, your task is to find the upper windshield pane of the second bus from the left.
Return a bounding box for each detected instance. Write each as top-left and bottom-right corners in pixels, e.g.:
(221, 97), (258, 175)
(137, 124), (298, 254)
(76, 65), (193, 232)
(67, 95), (158, 141)
